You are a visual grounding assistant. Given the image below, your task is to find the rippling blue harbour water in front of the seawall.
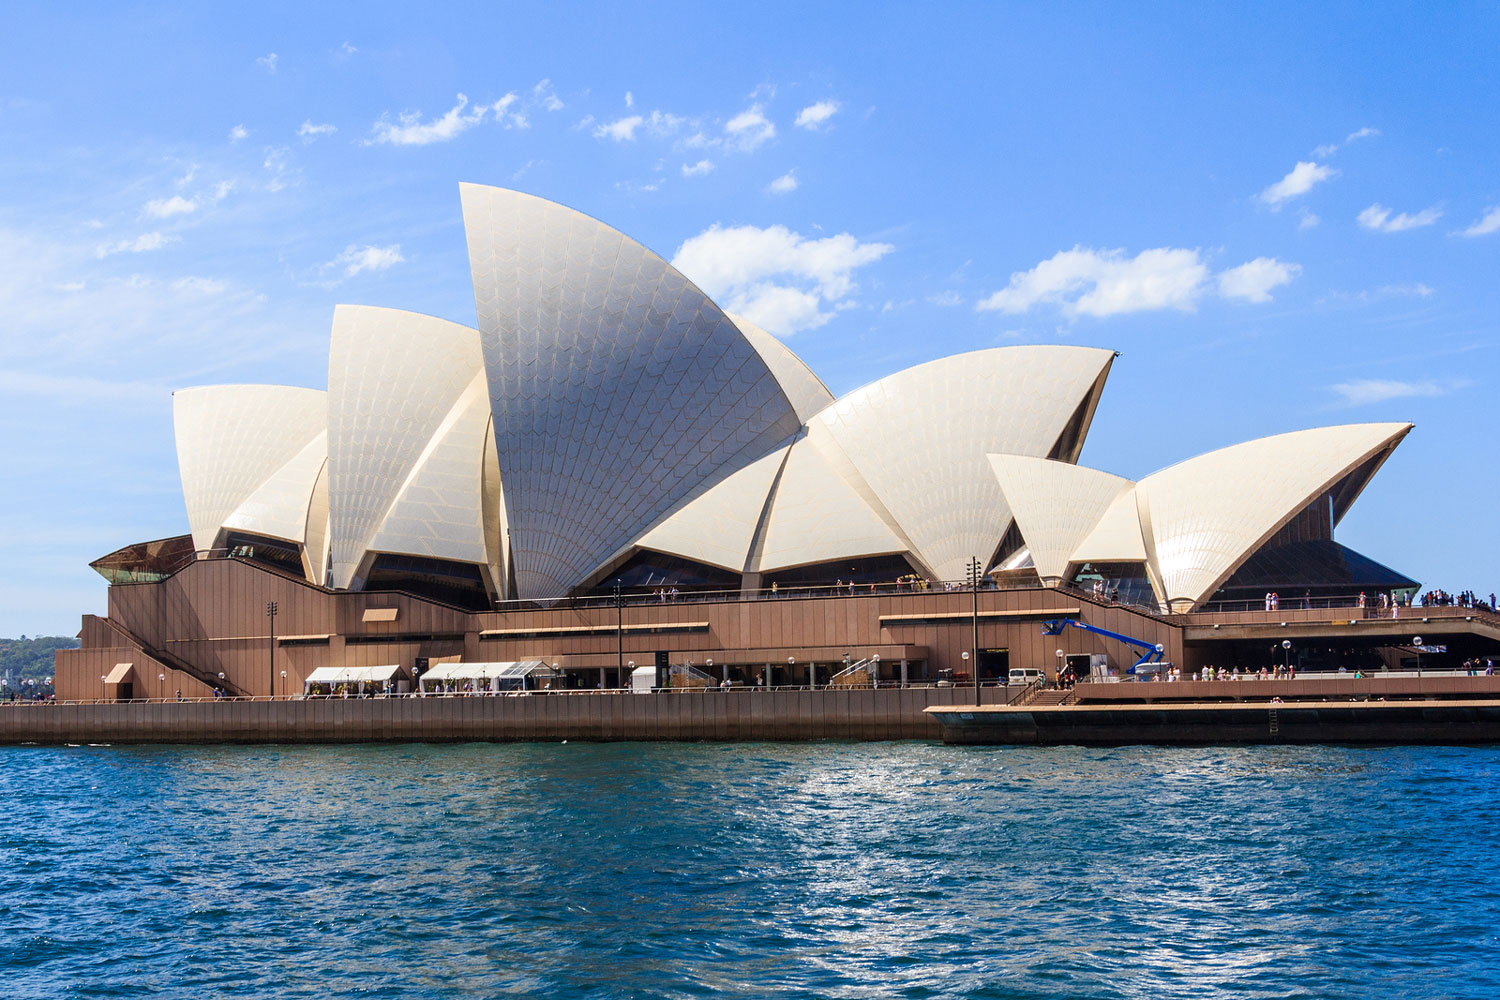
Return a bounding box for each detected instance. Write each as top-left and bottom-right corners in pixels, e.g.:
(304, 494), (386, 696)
(0, 744), (1500, 1000)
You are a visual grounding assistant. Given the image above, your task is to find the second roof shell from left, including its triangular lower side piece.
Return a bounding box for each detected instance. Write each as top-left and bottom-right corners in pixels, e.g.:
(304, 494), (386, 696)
(329, 306), (488, 589)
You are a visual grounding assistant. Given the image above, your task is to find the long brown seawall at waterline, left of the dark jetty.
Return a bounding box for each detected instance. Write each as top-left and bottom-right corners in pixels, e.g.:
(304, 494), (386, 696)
(0, 688), (1005, 744)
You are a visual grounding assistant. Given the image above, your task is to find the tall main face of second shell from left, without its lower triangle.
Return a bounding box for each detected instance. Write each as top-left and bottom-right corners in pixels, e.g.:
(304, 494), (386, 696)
(329, 306), (483, 588)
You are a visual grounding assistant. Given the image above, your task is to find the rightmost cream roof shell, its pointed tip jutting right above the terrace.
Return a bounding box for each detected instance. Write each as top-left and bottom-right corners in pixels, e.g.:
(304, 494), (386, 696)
(1136, 423), (1412, 610)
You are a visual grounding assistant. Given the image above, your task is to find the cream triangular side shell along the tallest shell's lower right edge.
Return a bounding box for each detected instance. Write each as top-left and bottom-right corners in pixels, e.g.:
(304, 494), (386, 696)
(641, 448), (786, 573)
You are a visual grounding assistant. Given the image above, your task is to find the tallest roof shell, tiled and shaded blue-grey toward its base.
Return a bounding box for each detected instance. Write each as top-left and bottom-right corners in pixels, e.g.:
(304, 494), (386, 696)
(461, 184), (801, 600)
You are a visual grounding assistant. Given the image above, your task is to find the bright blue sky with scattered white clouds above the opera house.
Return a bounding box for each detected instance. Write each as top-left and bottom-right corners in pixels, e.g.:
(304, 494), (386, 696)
(0, 1), (1500, 636)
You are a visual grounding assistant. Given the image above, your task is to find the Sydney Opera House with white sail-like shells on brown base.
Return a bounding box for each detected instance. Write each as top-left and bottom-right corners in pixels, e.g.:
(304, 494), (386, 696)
(59, 184), (1488, 697)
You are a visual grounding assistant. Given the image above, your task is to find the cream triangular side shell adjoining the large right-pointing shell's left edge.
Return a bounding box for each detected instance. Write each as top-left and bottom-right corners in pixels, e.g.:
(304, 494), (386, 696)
(758, 427), (909, 573)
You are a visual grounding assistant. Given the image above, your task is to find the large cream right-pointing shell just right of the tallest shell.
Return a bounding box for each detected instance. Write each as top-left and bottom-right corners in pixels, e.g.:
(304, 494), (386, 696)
(812, 346), (1115, 580)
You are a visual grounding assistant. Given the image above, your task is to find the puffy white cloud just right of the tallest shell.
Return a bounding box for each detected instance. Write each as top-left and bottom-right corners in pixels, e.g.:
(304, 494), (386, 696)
(672, 225), (896, 334)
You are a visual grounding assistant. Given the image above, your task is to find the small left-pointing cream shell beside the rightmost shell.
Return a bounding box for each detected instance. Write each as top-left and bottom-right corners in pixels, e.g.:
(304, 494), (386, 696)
(990, 454), (1140, 583)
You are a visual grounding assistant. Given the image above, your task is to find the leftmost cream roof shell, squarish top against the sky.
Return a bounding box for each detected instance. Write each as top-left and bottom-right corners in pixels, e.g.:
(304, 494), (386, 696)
(173, 385), (327, 550)
